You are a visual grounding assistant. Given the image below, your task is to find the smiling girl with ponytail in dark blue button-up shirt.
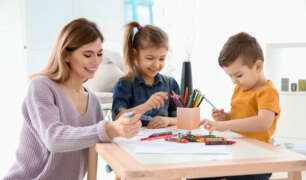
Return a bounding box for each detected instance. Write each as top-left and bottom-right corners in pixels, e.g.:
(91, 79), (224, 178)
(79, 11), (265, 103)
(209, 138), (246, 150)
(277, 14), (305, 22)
(112, 21), (179, 128)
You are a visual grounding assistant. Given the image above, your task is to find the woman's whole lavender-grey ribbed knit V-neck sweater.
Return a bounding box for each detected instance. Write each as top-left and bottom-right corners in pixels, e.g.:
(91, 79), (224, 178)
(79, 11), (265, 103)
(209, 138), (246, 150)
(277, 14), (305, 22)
(4, 76), (111, 180)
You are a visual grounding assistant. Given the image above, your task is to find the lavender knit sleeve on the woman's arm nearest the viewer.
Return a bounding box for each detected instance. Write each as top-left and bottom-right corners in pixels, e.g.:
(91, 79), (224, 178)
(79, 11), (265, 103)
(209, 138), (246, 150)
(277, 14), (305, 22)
(25, 79), (111, 152)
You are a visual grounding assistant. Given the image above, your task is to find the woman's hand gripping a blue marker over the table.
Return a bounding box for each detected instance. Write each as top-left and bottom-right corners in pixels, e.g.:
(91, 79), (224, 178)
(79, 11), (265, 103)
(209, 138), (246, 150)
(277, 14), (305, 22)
(112, 113), (141, 138)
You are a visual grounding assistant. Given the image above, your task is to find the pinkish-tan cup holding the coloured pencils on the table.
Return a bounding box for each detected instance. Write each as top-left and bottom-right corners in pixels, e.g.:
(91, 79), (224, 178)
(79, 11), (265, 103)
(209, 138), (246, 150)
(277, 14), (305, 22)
(176, 107), (200, 130)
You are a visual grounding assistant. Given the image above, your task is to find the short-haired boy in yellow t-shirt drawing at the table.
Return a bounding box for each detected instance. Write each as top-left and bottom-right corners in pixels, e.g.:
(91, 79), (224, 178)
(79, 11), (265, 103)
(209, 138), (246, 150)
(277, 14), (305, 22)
(203, 32), (280, 179)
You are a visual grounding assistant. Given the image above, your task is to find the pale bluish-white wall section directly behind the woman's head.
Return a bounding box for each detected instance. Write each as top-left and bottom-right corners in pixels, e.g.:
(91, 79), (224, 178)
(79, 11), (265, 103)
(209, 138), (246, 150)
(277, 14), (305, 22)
(21, 0), (124, 74)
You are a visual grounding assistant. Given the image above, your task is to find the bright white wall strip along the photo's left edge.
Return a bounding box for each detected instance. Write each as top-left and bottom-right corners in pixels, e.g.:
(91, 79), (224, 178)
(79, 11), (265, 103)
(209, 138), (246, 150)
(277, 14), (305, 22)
(0, 0), (26, 178)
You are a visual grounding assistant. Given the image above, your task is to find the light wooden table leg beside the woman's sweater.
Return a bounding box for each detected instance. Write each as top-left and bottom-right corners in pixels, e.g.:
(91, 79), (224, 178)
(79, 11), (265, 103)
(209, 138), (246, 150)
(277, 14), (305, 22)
(87, 145), (98, 180)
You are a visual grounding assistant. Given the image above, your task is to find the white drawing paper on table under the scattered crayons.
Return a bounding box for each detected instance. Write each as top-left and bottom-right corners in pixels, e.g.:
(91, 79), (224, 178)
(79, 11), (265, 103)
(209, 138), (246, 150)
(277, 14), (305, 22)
(114, 127), (237, 155)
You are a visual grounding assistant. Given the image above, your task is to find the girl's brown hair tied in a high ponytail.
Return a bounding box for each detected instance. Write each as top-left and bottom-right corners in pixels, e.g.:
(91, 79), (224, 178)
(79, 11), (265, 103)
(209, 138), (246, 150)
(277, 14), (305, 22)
(120, 21), (168, 81)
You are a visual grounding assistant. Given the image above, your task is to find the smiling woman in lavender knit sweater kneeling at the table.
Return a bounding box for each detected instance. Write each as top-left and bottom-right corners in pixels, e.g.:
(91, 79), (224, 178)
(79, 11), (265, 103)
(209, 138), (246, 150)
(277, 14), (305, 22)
(4, 18), (141, 180)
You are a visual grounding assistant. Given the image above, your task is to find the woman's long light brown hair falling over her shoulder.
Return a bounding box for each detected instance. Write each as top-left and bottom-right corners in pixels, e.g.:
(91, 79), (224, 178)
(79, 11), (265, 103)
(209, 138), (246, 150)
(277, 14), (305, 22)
(29, 18), (104, 83)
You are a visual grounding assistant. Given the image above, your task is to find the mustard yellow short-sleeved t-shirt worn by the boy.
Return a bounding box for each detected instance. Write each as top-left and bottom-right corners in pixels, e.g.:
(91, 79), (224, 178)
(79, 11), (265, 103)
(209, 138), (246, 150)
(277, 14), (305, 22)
(230, 80), (280, 143)
